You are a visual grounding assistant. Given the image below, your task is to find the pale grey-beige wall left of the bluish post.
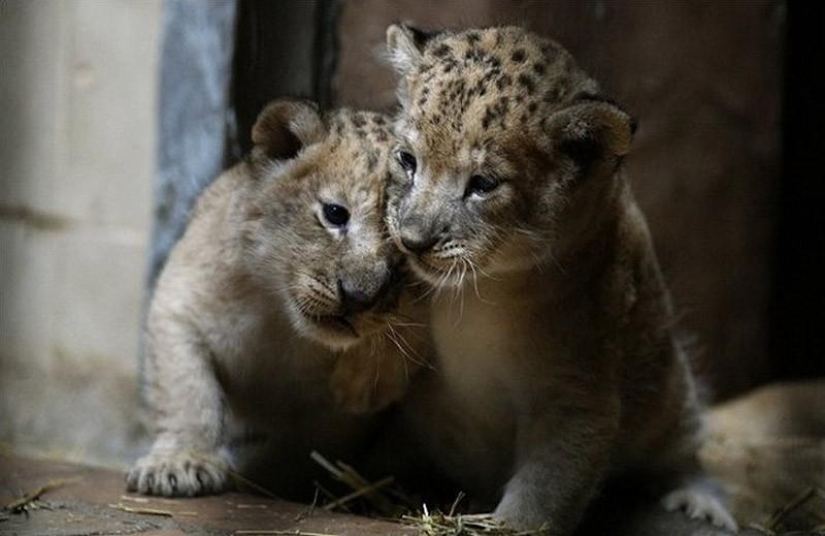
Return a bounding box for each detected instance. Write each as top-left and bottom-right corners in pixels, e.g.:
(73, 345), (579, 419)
(0, 0), (162, 464)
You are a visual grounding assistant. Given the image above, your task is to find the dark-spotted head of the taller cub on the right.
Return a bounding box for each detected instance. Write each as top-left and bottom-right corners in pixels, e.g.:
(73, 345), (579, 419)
(387, 25), (634, 285)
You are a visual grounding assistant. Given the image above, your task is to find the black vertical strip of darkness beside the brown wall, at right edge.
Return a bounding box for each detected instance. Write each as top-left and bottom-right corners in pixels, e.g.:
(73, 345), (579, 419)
(768, 2), (825, 386)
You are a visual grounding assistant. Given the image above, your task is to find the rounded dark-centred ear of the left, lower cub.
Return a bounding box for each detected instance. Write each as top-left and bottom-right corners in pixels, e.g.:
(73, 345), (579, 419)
(252, 99), (325, 160)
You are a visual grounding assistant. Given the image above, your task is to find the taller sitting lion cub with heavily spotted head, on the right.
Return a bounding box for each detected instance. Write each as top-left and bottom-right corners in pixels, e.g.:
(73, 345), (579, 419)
(387, 25), (735, 535)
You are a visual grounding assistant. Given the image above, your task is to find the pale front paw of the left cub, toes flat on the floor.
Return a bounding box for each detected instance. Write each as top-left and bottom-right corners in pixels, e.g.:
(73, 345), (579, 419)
(126, 452), (229, 497)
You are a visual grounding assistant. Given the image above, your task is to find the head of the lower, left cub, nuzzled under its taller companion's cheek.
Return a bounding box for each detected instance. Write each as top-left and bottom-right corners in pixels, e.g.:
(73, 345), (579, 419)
(244, 100), (401, 348)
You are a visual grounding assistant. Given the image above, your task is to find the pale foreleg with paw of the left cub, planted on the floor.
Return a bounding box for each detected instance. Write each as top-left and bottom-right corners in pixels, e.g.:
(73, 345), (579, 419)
(126, 318), (229, 497)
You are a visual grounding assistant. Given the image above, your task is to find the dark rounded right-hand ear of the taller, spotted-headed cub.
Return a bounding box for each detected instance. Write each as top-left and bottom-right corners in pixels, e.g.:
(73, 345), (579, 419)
(544, 96), (636, 166)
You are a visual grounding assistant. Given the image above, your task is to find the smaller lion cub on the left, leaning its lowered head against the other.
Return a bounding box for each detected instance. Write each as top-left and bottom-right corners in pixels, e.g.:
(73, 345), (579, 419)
(127, 101), (432, 497)
